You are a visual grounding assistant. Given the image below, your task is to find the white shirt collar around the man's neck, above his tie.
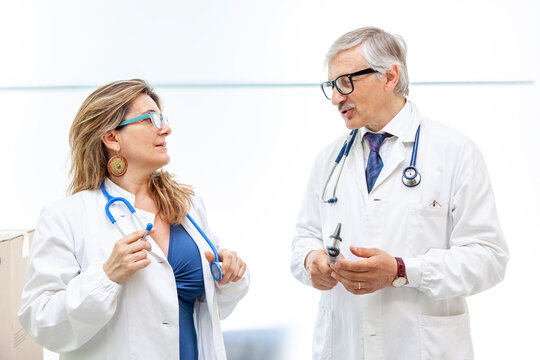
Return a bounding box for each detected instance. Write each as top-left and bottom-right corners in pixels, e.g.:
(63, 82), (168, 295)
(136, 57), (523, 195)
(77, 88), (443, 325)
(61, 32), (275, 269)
(360, 100), (420, 142)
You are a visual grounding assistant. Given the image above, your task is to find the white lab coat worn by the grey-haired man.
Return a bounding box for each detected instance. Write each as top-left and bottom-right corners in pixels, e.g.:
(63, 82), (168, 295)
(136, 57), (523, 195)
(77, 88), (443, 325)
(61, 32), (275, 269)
(291, 103), (508, 360)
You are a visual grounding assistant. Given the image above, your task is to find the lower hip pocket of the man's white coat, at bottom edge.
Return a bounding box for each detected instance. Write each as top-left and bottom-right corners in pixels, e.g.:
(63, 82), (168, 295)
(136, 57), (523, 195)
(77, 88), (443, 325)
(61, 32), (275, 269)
(420, 312), (474, 360)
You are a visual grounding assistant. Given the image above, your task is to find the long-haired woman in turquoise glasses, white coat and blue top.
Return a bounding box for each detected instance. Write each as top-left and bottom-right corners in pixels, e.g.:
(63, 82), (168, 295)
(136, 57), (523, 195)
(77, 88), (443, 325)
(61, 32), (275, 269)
(19, 79), (249, 360)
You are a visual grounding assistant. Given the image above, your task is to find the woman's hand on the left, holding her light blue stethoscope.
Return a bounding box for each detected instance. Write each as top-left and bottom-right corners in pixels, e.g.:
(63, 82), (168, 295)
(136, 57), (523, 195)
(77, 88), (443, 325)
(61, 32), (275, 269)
(103, 230), (152, 284)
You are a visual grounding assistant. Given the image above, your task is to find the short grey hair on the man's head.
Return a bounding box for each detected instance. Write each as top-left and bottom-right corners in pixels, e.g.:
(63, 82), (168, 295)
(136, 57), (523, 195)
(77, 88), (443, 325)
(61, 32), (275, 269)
(325, 27), (409, 97)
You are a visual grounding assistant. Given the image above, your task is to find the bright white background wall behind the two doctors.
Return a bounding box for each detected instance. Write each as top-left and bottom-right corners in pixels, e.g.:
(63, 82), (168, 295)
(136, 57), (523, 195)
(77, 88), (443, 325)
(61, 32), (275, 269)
(0, 0), (540, 359)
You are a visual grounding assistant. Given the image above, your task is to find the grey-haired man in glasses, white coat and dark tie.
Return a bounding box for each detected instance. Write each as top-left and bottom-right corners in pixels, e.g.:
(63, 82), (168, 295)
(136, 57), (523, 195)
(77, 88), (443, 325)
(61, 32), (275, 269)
(291, 27), (508, 360)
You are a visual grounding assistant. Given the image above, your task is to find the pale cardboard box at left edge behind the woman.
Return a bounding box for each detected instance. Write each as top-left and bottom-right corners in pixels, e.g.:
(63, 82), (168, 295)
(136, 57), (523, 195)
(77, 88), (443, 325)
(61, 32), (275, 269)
(0, 230), (43, 360)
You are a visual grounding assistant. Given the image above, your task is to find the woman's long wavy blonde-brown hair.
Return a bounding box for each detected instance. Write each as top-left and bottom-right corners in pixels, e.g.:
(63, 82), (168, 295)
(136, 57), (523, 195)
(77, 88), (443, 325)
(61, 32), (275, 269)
(68, 79), (194, 225)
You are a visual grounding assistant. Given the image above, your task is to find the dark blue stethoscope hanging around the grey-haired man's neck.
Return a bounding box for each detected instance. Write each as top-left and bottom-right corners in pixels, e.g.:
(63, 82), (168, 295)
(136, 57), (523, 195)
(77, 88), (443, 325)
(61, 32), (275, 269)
(321, 125), (422, 204)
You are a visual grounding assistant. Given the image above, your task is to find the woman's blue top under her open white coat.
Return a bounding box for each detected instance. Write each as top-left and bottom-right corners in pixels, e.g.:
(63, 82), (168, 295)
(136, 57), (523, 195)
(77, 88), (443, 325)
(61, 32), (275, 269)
(167, 225), (204, 360)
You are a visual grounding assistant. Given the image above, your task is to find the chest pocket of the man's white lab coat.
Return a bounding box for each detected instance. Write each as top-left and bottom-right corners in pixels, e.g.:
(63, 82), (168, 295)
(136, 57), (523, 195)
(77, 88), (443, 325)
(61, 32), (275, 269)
(407, 204), (449, 256)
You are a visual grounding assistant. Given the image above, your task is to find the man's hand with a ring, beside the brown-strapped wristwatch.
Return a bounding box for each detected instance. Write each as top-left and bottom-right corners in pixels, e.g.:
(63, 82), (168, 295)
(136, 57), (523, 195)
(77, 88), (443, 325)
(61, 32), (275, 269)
(331, 246), (397, 295)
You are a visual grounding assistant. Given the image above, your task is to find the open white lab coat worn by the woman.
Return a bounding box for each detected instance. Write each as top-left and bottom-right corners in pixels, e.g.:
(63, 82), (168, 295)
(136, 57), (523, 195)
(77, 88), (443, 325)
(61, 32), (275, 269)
(19, 179), (249, 360)
